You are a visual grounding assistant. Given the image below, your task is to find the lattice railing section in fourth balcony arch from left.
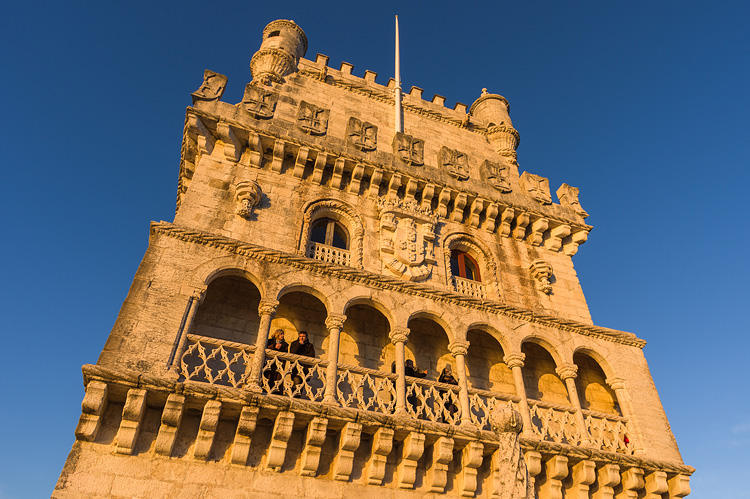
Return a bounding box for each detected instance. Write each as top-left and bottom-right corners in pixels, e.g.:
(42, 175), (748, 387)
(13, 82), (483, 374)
(406, 376), (461, 425)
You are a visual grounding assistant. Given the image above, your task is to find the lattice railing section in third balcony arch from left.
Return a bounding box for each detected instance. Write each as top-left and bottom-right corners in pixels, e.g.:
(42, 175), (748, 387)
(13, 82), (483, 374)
(336, 364), (396, 414)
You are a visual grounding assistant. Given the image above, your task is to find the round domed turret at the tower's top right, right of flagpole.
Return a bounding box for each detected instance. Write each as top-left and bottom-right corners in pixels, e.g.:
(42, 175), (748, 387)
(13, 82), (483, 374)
(469, 88), (520, 160)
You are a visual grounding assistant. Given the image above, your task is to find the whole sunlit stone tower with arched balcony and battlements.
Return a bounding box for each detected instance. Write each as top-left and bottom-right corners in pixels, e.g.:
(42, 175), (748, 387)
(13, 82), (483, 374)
(53, 20), (693, 499)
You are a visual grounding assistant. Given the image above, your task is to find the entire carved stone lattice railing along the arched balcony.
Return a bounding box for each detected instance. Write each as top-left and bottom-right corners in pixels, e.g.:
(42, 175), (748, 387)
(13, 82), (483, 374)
(180, 334), (635, 454)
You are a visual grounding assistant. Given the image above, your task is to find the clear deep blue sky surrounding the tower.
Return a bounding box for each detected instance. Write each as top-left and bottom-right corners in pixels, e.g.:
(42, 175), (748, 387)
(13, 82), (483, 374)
(0, 1), (750, 499)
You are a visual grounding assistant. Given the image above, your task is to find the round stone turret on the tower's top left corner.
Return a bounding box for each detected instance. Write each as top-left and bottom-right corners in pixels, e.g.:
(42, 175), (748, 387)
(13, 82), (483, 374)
(250, 19), (307, 85)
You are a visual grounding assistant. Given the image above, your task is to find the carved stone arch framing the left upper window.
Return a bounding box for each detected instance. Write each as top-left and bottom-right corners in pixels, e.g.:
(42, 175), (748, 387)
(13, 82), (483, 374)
(297, 198), (365, 269)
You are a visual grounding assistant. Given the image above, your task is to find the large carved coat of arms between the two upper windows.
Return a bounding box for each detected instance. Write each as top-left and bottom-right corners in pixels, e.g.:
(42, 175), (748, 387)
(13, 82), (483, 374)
(379, 197), (437, 281)
